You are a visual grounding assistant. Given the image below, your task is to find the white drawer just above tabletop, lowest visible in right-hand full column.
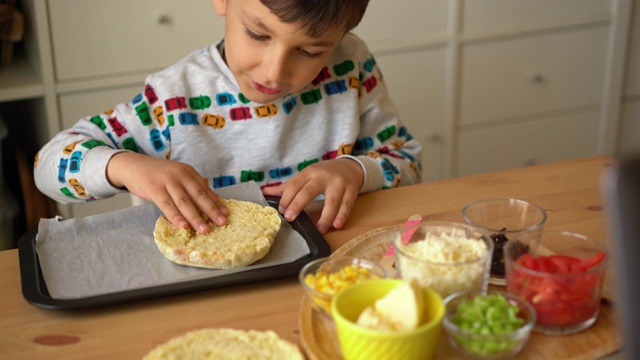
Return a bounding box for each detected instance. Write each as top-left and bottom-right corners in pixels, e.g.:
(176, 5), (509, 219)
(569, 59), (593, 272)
(456, 111), (598, 176)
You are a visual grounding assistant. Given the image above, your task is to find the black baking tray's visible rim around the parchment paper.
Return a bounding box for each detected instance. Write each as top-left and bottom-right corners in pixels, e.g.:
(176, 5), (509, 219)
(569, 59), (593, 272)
(18, 196), (331, 310)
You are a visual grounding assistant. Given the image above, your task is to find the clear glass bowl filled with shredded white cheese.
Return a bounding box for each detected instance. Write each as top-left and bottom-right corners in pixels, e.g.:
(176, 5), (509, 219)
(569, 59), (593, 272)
(394, 221), (493, 297)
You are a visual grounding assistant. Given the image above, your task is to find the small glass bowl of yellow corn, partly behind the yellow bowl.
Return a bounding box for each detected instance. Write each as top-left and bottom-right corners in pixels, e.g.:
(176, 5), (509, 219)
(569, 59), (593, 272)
(298, 256), (389, 317)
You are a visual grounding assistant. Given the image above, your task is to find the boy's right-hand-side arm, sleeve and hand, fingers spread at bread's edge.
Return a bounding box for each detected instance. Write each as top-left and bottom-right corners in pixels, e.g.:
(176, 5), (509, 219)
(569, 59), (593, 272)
(263, 45), (422, 233)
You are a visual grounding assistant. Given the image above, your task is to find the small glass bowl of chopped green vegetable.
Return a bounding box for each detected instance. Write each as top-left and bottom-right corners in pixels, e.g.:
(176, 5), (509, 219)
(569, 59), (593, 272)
(443, 291), (536, 359)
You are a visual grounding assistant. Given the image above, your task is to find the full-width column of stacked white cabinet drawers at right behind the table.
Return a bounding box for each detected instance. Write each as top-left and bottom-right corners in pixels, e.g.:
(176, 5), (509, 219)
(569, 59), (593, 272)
(448, 0), (619, 176)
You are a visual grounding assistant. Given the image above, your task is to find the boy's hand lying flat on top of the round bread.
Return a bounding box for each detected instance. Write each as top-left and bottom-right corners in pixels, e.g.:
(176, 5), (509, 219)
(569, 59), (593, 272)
(107, 152), (228, 234)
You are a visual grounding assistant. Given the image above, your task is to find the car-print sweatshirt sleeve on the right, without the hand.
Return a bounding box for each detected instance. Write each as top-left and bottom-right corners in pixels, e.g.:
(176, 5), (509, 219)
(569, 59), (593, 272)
(340, 50), (422, 193)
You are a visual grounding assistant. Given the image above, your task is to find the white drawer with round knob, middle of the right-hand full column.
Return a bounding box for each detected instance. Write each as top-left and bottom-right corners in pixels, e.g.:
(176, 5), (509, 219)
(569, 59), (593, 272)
(460, 27), (608, 126)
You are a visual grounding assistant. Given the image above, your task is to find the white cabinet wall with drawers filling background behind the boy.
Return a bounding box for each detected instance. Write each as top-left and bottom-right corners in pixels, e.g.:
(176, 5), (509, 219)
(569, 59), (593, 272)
(0, 0), (640, 221)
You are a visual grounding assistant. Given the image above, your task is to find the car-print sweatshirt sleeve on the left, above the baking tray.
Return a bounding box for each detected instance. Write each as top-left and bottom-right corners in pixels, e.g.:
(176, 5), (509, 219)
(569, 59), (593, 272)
(34, 80), (170, 203)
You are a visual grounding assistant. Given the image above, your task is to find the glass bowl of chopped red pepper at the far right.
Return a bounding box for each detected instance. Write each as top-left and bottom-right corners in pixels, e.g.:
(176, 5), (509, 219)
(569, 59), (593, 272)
(504, 230), (608, 334)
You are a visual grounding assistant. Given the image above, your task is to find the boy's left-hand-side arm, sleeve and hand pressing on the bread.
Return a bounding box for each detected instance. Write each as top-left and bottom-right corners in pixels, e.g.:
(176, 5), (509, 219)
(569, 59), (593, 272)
(34, 77), (228, 233)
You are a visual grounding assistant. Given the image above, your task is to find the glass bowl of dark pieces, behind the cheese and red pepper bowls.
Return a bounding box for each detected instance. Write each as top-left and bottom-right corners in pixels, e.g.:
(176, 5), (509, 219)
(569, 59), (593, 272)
(462, 198), (547, 286)
